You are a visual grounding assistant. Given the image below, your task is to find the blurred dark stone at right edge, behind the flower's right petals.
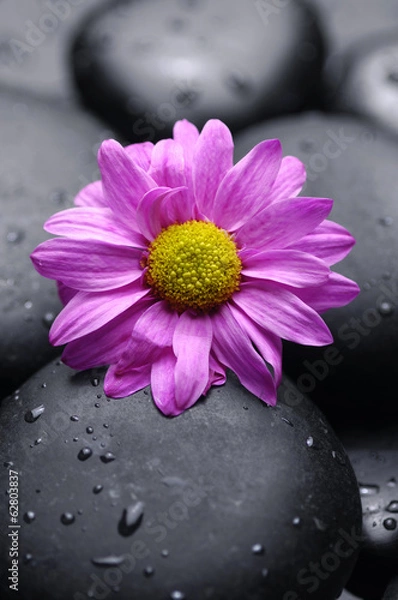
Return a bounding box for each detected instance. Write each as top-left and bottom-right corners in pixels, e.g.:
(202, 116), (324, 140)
(236, 113), (398, 427)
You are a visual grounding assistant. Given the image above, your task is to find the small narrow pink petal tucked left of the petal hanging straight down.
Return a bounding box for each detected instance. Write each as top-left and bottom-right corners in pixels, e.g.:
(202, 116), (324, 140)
(151, 348), (179, 416)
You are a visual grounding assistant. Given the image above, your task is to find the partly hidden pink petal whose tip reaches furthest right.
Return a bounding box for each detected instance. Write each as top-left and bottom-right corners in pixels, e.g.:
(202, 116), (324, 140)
(295, 272), (360, 312)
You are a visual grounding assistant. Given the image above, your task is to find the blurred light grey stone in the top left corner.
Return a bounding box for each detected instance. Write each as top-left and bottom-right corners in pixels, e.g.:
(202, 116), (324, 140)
(0, 0), (109, 99)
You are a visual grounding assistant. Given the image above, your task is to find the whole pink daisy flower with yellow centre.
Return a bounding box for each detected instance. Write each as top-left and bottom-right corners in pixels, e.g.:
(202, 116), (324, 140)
(32, 120), (359, 415)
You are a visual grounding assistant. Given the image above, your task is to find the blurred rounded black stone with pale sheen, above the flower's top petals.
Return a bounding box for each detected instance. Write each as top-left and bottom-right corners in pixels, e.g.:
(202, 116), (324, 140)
(73, 0), (323, 141)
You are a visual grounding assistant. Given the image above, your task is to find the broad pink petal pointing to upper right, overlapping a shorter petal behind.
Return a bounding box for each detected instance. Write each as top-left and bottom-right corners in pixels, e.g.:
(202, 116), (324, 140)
(211, 140), (282, 231)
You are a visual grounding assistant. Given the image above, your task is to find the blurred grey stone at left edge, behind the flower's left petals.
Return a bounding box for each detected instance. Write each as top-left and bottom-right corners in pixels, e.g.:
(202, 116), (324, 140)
(0, 92), (116, 398)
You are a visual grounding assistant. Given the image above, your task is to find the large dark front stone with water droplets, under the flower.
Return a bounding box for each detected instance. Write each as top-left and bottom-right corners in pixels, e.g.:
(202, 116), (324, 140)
(0, 362), (361, 600)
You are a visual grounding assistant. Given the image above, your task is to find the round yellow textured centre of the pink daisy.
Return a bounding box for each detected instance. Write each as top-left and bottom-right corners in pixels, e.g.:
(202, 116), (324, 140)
(146, 221), (242, 312)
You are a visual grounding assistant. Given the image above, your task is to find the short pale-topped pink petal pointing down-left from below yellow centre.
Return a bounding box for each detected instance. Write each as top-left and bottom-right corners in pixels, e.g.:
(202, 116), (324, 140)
(117, 300), (178, 373)
